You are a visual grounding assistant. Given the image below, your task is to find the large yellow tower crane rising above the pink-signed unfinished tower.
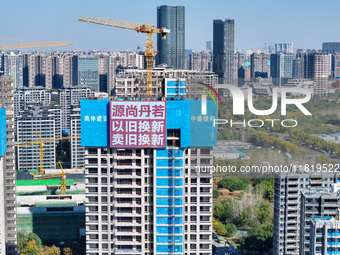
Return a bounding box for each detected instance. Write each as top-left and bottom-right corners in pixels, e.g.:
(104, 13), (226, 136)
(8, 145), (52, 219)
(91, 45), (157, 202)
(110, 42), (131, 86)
(78, 16), (170, 97)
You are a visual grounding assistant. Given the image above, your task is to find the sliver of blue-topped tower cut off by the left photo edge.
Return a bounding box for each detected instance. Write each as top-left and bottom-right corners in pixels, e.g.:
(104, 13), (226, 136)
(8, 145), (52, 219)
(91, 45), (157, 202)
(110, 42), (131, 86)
(0, 108), (7, 254)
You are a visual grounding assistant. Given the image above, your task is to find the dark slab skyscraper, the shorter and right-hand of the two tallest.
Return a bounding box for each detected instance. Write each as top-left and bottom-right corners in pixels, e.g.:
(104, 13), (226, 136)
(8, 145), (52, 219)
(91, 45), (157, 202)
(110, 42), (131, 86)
(213, 19), (234, 84)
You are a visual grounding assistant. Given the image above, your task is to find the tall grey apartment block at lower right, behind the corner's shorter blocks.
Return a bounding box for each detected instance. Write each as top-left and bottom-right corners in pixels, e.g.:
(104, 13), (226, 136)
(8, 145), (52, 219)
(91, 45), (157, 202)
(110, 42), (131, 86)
(273, 172), (339, 255)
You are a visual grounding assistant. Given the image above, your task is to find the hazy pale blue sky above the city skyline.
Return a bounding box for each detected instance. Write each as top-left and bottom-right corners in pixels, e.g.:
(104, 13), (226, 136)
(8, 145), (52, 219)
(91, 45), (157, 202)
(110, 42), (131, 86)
(0, 0), (340, 51)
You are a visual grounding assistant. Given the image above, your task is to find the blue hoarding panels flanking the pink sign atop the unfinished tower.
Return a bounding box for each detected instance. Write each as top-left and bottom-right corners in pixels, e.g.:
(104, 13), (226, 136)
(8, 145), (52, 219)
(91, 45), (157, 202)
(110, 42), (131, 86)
(81, 99), (217, 148)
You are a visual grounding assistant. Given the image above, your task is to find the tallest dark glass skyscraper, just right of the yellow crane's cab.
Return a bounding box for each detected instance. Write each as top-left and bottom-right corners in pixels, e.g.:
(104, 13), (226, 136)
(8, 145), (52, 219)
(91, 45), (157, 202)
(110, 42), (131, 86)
(157, 5), (185, 69)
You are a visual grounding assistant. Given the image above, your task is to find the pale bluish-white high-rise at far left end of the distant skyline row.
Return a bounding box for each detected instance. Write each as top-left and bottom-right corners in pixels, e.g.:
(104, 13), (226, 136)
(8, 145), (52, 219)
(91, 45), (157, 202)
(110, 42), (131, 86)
(1, 51), (23, 88)
